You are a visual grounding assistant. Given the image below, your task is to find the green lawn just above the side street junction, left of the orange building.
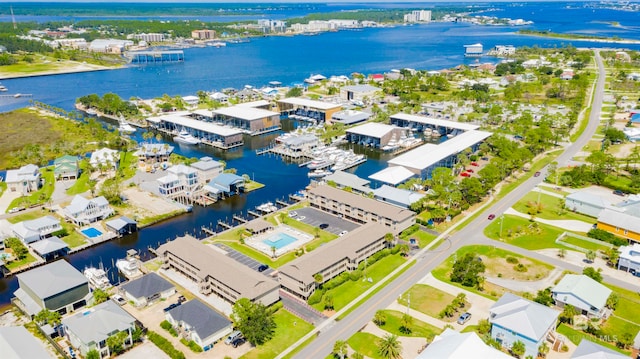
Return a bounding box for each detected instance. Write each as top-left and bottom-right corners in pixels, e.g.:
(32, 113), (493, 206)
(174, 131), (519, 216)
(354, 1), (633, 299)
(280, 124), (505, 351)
(484, 215), (568, 250)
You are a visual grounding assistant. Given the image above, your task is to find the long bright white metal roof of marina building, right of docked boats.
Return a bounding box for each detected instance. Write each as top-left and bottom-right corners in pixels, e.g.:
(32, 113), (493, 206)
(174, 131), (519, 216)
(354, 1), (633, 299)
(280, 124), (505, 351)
(388, 130), (492, 170)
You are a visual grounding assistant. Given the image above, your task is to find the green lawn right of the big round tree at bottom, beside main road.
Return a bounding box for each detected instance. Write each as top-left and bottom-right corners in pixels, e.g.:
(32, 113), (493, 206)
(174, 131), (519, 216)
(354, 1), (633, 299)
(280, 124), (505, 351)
(241, 308), (313, 359)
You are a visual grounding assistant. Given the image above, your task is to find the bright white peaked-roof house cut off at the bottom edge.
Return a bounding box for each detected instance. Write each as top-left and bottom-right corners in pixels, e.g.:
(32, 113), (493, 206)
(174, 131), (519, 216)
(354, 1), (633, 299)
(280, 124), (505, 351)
(416, 328), (512, 359)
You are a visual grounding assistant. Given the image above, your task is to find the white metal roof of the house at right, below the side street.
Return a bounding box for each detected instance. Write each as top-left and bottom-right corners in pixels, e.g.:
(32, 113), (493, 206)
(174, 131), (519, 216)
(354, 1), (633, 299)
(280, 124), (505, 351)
(551, 274), (611, 310)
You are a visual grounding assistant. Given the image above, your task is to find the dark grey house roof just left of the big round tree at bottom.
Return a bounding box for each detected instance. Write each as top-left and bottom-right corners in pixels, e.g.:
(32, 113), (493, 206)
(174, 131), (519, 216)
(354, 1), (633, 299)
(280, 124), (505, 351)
(167, 299), (233, 340)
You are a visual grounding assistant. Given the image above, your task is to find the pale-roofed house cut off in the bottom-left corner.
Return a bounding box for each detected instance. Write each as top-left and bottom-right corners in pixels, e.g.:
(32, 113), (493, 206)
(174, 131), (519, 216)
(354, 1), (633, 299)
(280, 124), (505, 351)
(0, 326), (55, 359)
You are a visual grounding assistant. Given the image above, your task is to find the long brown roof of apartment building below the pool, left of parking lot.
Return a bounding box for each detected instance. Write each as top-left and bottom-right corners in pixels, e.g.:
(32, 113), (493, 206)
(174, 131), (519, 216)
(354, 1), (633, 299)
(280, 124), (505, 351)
(157, 235), (280, 300)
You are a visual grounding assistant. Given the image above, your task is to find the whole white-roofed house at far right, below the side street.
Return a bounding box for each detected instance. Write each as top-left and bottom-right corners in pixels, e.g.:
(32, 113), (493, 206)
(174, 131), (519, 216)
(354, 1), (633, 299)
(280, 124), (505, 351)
(551, 274), (611, 318)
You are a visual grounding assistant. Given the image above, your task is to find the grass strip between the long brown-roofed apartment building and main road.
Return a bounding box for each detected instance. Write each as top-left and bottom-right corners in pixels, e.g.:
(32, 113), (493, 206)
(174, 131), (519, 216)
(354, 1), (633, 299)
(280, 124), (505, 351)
(313, 254), (406, 311)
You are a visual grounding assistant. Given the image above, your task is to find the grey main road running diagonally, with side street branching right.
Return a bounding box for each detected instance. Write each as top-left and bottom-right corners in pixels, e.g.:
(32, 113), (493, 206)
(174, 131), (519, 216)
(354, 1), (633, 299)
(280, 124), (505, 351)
(294, 51), (624, 359)
